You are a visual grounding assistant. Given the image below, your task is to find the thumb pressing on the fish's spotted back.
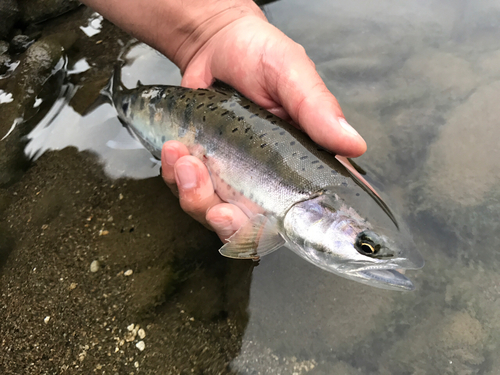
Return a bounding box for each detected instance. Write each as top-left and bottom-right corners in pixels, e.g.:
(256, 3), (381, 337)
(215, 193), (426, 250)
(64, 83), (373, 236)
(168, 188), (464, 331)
(263, 40), (366, 157)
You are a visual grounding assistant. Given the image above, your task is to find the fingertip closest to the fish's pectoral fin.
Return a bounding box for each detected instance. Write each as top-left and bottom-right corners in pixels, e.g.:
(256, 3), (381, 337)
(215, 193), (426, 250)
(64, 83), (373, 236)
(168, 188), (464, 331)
(206, 203), (248, 242)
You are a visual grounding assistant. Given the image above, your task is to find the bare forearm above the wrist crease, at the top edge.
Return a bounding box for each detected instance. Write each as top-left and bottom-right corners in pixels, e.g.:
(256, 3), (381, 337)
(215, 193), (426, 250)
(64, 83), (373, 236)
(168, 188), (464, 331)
(81, 0), (267, 71)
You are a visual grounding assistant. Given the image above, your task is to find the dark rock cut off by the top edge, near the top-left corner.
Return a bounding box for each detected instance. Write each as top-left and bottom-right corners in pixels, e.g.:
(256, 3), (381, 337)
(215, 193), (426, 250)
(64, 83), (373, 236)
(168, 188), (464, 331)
(19, 0), (81, 23)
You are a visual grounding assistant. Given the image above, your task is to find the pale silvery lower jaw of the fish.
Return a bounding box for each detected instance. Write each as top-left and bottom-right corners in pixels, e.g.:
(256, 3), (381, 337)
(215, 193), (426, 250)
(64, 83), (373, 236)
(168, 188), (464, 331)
(349, 269), (415, 291)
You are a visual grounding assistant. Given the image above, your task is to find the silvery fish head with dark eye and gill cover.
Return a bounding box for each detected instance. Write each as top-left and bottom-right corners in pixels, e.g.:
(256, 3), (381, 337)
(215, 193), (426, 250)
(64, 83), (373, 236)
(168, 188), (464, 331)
(283, 191), (424, 290)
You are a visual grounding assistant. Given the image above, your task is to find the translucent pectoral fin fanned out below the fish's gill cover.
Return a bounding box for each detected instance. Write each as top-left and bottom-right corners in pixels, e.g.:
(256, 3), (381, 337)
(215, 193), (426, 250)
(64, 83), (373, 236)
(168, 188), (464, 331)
(219, 214), (285, 260)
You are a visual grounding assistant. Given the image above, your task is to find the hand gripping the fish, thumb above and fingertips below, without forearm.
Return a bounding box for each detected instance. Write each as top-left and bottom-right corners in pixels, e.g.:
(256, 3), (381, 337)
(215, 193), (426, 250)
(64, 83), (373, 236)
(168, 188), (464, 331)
(162, 14), (366, 241)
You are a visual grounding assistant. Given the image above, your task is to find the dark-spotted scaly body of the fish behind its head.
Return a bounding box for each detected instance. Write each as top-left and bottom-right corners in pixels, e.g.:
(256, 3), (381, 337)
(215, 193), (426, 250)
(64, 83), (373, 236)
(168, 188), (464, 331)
(117, 86), (353, 214)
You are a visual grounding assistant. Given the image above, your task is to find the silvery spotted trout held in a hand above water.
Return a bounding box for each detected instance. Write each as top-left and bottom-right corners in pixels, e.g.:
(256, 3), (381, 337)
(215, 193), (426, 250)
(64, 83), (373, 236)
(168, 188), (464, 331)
(107, 69), (424, 291)
